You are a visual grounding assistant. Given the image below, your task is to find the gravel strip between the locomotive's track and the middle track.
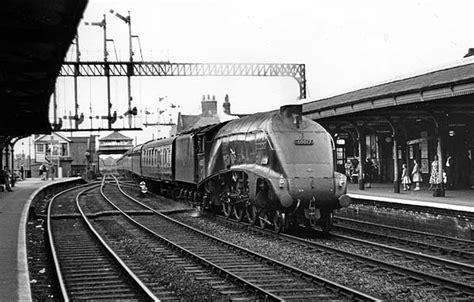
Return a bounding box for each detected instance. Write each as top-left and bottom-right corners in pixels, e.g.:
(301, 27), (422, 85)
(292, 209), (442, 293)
(172, 213), (462, 301)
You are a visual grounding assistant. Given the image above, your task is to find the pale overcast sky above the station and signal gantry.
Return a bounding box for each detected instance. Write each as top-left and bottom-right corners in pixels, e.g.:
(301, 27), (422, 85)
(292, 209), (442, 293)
(14, 0), (474, 158)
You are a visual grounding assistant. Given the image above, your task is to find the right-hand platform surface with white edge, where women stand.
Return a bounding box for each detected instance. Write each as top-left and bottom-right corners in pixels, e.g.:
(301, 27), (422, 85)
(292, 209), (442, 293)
(347, 183), (474, 212)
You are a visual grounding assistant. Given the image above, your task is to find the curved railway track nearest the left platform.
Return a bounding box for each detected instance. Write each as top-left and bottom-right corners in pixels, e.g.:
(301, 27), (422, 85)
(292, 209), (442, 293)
(47, 179), (157, 301)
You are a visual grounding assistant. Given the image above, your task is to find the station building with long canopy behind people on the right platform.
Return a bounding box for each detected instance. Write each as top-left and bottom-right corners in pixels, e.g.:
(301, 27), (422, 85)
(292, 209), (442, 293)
(303, 56), (474, 194)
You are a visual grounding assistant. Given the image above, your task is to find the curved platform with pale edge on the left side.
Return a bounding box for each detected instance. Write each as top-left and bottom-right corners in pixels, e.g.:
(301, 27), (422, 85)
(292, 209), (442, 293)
(0, 178), (78, 301)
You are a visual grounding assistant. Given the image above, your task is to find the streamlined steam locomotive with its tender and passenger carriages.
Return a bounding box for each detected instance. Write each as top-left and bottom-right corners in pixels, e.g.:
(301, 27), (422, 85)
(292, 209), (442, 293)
(118, 105), (351, 232)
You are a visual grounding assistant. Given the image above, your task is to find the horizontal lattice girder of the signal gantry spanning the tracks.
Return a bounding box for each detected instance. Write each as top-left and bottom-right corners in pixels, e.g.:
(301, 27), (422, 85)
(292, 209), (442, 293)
(59, 61), (306, 99)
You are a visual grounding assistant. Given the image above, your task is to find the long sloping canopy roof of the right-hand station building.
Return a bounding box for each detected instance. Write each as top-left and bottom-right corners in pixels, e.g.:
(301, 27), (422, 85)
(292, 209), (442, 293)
(303, 57), (474, 120)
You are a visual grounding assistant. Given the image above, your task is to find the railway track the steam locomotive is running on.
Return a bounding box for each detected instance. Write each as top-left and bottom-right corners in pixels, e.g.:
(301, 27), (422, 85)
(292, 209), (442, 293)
(175, 206), (474, 300)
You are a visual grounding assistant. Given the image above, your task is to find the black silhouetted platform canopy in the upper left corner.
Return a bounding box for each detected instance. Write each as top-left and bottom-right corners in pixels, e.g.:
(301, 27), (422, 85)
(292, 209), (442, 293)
(0, 0), (88, 138)
